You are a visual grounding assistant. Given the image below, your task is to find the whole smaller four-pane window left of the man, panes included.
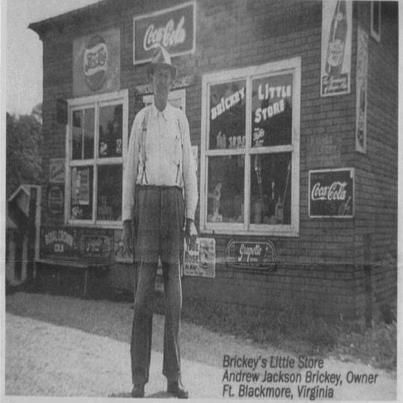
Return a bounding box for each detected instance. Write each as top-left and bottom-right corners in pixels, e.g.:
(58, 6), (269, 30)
(66, 91), (128, 226)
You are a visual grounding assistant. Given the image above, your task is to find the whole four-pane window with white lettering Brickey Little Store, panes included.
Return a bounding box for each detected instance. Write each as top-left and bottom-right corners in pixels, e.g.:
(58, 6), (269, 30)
(200, 58), (300, 235)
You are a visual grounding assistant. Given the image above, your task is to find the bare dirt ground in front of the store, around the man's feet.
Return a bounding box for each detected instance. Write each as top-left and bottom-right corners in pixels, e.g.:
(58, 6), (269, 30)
(5, 293), (396, 402)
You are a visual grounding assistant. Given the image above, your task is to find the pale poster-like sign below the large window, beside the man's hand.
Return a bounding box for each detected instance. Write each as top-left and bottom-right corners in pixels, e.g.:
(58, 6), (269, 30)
(184, 238), (216, 278)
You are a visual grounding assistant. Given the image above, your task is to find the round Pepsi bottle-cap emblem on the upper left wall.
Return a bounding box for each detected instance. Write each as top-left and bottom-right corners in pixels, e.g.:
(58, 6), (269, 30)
(83, 35), (108, 91)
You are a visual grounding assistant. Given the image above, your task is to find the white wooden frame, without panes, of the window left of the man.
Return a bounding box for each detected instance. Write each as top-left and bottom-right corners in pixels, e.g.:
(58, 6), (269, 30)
(64, 89), (129, 229)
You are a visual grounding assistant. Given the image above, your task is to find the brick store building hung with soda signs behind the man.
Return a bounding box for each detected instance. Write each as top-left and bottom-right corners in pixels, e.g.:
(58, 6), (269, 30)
(29, 0), (398, 318)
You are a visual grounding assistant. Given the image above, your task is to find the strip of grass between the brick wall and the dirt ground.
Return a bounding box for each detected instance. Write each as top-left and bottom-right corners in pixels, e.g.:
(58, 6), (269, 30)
(155, 296), (397, 370)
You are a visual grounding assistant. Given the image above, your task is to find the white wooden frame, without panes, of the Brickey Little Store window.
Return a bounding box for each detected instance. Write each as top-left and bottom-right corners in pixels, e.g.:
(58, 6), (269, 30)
(200, 57), (301, 237)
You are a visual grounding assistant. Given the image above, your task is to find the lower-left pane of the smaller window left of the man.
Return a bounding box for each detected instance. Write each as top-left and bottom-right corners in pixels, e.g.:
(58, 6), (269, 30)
(71, 167), (93, 220)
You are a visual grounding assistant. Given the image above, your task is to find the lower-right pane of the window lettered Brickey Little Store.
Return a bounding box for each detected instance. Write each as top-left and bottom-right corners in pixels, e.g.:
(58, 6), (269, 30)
(250, 153), (291, 225)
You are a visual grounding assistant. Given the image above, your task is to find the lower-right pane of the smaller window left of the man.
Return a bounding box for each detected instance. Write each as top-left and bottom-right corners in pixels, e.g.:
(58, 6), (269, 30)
(97, 165), (122, 221)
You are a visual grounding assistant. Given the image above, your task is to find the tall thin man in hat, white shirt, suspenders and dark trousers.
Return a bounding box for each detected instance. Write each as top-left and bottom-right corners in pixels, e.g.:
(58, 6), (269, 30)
(123, 47), (198, 399)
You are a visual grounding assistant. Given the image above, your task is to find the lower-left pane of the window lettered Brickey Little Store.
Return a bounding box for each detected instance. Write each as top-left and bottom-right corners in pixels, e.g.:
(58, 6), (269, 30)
(207, 155), (245, 223)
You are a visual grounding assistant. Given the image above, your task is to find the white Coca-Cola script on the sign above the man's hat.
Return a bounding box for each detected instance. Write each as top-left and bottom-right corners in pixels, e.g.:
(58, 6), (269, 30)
(143, 17), (186, 51)
